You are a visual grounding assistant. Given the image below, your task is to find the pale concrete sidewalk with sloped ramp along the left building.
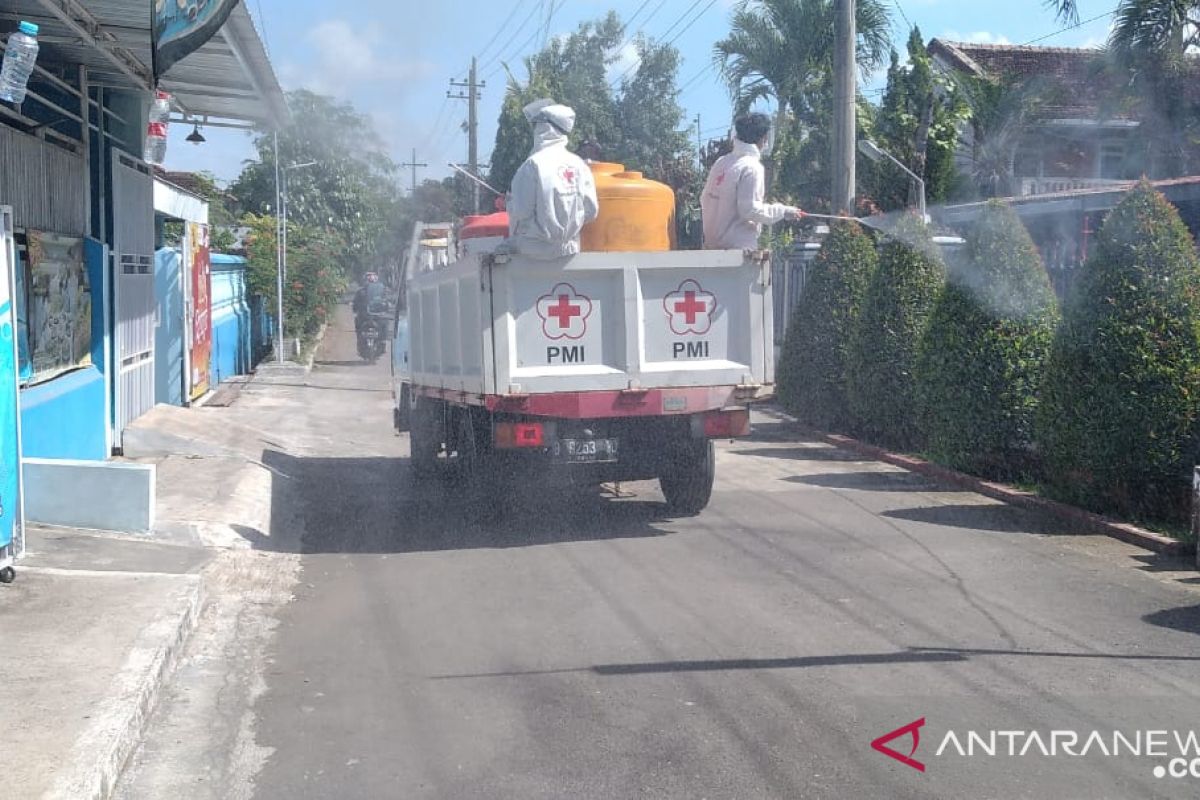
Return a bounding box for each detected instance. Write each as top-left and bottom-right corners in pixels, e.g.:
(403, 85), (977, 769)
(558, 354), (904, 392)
(0, 366), (306, 800)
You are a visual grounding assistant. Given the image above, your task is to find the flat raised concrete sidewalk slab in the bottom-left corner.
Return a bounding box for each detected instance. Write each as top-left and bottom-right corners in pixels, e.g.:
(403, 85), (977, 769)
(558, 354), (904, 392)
(0, 528), (209, 800)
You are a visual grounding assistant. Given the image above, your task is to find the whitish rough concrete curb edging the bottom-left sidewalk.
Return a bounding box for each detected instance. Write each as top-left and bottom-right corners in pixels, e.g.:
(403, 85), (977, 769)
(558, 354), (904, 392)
(44, 573), (204, 800)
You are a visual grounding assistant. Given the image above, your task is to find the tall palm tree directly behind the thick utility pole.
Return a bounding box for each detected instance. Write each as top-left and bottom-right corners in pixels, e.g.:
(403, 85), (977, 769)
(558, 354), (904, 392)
(713, 0), (890, 207)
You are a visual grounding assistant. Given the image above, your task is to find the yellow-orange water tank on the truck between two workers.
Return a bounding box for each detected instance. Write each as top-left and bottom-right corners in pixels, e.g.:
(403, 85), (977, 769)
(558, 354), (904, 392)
(580, 161), (674, 252)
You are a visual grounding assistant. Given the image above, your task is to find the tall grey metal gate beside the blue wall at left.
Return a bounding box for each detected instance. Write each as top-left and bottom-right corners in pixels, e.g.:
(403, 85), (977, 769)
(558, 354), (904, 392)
(113, 149), (157, 441)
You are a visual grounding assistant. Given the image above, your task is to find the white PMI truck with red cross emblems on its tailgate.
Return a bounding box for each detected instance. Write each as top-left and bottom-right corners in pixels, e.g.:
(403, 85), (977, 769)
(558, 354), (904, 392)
(392, 223), (774, 515)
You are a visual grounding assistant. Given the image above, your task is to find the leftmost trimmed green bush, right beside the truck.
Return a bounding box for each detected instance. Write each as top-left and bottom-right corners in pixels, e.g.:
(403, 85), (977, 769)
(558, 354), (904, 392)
(779, 223), (877, 431)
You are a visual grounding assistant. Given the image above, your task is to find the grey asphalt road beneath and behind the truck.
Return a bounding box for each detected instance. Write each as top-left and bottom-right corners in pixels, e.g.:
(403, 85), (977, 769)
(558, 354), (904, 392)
(117, 311), (1200, 800)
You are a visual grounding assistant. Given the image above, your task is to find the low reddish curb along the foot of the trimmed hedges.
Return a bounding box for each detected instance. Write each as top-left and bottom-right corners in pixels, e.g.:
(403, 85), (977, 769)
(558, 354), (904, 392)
(775, 411), (1196, 558)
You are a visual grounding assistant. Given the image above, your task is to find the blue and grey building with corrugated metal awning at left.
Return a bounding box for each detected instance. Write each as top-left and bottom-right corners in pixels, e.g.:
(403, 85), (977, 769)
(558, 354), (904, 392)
(0, 0), (287, 544)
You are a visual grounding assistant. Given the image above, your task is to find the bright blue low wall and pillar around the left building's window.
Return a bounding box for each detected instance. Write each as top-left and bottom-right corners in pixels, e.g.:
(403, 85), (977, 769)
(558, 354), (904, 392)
(20, 239), (108, 461)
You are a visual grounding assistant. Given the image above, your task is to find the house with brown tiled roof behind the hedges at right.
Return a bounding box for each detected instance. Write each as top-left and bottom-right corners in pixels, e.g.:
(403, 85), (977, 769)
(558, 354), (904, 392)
(929, 38), (1177, 197)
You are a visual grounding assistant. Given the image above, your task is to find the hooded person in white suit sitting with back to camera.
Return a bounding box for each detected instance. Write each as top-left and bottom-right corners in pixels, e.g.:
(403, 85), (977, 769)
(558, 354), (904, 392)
(505, 100), (600, 259)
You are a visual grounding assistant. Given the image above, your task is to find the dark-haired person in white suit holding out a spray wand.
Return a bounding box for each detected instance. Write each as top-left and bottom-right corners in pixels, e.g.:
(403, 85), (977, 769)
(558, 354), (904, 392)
(700, 114), (803, 249)
